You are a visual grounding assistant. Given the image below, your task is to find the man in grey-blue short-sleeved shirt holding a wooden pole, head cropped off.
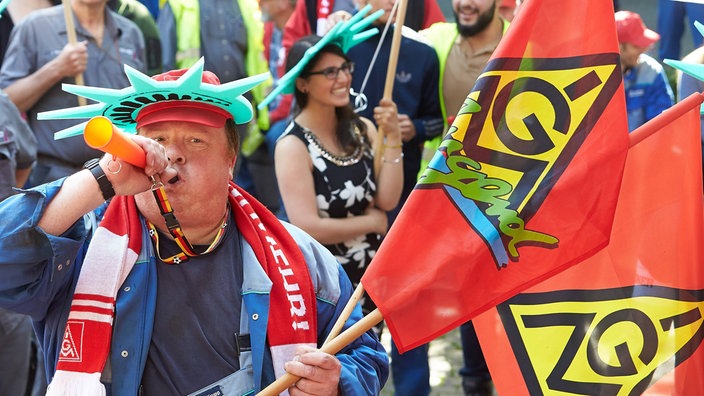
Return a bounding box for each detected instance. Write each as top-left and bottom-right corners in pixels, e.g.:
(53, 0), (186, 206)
(0, 0), (145, 186)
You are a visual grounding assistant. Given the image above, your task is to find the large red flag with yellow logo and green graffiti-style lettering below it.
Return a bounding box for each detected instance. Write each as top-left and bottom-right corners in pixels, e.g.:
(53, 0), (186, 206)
(362, 0), (628, 351)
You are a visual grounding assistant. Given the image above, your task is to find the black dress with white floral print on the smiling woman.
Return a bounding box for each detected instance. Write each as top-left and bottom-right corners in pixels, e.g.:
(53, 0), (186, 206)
(287, 122), (382, 311)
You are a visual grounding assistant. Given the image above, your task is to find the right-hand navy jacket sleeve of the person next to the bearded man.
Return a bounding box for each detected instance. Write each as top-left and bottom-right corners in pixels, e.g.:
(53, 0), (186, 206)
(412, 47), (444, 142)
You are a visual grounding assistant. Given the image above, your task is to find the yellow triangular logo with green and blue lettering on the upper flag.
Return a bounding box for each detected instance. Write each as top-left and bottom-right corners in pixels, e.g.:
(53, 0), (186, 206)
(416, 53), (621, 269)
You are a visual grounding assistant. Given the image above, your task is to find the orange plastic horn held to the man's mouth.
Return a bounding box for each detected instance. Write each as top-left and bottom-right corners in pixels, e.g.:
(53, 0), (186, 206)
(83, 116), (147, 168)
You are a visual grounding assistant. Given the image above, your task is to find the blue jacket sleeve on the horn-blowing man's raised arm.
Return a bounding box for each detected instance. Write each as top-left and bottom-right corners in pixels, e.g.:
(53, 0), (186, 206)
(0, 179), (86, 320)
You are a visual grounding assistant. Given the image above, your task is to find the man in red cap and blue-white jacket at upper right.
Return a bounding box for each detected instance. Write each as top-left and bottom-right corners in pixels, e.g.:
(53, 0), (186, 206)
(615, 10), (674, 131)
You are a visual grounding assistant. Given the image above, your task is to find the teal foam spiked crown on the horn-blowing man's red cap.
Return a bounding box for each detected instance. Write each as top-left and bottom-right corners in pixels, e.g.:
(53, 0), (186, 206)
(37, 58), (269, 140)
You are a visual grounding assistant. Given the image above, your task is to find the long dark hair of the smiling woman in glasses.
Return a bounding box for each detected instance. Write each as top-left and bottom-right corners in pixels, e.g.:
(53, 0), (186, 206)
(286, 35), (369, 152)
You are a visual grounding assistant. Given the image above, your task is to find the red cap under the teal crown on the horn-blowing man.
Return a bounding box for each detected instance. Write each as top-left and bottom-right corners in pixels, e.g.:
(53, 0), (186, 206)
(135, 69), (233, 129)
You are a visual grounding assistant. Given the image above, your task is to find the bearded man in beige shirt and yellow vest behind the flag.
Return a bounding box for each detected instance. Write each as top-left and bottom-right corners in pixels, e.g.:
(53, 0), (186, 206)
(420, 0), (508, 395)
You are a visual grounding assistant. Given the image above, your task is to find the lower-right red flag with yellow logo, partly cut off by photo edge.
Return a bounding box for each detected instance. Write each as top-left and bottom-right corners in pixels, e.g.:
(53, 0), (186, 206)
(473, 94), (704, 395)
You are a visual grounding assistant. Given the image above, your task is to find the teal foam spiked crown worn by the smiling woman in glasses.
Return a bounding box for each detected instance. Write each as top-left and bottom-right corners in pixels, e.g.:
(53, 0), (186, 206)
(257, 4), (384, 110)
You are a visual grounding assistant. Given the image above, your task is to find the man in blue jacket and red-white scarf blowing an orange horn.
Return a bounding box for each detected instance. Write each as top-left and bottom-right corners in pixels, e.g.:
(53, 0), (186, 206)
(0, 63), (388, 395)
